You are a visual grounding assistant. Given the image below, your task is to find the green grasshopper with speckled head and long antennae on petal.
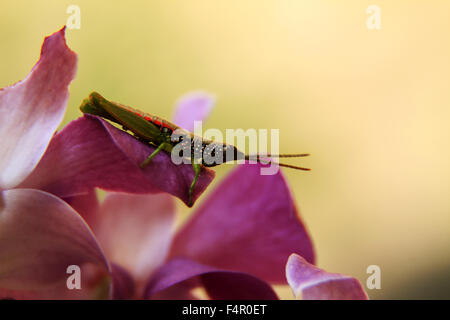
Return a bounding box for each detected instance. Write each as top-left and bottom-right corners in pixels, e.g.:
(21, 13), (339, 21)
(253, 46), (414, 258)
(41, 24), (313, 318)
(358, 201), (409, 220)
(80, 92), (310, 207)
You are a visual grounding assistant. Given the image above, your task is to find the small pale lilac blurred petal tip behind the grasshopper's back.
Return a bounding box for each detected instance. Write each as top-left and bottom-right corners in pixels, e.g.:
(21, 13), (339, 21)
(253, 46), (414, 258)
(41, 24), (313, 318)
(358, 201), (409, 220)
(173, 92), (215, 132)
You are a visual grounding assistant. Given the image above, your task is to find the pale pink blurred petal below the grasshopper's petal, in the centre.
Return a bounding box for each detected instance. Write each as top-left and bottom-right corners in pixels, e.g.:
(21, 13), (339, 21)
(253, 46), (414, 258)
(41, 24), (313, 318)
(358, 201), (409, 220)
(94, 193), (175, 282)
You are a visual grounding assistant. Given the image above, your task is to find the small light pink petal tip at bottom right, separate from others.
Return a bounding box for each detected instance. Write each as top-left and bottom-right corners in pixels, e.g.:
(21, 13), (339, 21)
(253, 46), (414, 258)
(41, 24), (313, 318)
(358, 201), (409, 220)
(286, 254), (367, 300)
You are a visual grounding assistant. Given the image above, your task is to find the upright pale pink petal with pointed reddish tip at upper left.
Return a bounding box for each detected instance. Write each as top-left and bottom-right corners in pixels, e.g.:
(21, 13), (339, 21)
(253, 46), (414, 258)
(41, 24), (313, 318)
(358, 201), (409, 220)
(0, 28), (77, 189)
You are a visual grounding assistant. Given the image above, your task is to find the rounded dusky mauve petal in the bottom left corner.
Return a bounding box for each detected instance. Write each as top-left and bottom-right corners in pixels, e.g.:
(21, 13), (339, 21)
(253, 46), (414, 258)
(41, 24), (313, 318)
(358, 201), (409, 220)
(0, 189), (109, 290)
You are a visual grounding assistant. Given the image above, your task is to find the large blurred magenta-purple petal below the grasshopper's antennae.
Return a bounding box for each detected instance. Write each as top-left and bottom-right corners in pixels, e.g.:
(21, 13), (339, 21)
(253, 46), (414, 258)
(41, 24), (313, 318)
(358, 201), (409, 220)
(171, 164), (314, 283)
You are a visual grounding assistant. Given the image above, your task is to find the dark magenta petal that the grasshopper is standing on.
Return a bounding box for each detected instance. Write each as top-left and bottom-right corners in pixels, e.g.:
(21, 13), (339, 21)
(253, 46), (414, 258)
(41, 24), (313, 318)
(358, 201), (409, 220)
(21, 116), (214, 203)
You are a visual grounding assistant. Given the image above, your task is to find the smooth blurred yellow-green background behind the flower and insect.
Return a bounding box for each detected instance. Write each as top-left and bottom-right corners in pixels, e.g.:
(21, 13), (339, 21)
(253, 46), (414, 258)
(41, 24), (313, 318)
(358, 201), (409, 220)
(0, 0), (450, 299)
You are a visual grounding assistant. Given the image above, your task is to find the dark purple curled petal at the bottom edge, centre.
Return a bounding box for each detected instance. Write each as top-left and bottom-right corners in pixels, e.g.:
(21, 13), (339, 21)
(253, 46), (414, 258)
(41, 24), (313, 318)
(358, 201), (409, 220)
(145, 258), (277, 300)
